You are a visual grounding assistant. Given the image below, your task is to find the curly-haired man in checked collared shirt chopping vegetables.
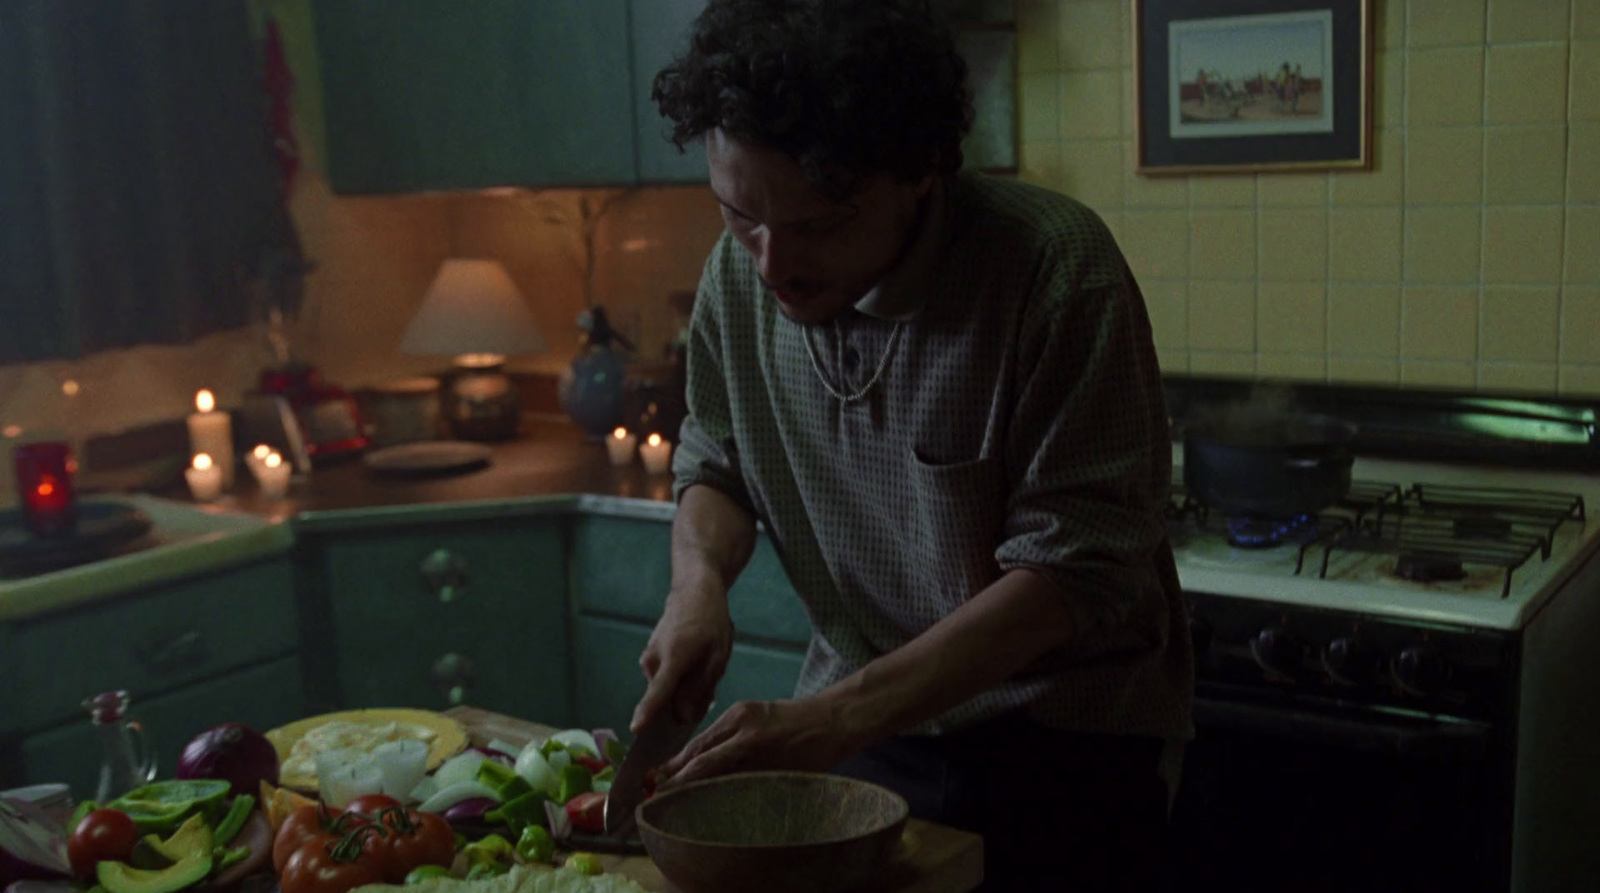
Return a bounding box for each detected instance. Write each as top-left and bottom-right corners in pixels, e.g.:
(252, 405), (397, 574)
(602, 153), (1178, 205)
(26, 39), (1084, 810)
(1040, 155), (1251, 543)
(632, 0), (1194, 890)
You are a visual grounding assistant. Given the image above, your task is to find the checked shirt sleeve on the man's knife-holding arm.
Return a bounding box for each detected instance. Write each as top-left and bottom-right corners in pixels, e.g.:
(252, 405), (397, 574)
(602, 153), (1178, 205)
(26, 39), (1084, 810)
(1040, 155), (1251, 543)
(672, 238), (755, 515)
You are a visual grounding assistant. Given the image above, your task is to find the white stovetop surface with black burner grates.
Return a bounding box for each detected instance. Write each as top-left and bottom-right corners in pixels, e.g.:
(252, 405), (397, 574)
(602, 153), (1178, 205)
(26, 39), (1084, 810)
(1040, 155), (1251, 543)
(1168, 457), (1600, 631)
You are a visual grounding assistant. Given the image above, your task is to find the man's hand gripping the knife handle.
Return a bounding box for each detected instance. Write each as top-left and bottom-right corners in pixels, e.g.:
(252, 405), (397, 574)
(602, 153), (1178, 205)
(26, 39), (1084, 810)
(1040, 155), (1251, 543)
(629, 589), (733, 735)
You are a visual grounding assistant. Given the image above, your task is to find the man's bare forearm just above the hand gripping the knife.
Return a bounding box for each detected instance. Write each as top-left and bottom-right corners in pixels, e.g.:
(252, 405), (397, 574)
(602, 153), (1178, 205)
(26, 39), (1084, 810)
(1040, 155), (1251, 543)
(672, 485), (755, 597)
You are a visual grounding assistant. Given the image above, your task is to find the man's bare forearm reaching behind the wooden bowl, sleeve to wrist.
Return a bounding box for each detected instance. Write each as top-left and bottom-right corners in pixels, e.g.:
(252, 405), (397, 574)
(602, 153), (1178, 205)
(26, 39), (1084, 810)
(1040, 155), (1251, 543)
(818, 570), (1080, 749)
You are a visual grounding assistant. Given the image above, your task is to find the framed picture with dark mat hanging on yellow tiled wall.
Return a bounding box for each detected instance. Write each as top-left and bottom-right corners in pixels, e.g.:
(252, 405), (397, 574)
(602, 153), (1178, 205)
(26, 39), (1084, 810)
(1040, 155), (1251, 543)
(1131, 0), (1373, 176)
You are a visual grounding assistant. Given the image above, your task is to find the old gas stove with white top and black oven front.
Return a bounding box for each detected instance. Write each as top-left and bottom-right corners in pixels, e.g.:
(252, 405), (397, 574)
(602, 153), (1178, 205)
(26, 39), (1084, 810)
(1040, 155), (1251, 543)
(1166, 379), (1600, 893)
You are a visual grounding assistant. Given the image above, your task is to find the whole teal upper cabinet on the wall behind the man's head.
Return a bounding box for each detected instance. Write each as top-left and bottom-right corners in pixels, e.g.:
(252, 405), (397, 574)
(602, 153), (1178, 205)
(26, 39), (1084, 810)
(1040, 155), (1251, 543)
(314, 0), (1016, 194)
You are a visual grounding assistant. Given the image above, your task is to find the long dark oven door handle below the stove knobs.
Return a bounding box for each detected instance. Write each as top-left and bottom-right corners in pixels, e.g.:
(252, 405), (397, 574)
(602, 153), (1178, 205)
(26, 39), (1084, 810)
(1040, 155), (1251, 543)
(1194, 696), (1491, 757)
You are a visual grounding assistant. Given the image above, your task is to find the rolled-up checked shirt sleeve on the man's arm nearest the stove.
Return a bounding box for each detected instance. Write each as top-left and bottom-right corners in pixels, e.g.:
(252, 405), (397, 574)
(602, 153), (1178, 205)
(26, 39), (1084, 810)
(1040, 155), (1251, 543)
(995, 246), (1171, 627)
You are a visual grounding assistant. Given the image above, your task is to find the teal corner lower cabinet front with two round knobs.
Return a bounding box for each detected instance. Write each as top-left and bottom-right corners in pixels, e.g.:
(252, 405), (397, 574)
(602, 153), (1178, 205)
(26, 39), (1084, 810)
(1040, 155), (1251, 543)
(298, 514), (571, 725)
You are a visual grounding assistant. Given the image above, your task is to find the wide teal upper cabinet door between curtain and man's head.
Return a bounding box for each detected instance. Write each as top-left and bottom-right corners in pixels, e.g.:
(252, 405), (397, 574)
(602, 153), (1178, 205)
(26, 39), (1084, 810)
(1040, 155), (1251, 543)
(315, 0), (634, 194)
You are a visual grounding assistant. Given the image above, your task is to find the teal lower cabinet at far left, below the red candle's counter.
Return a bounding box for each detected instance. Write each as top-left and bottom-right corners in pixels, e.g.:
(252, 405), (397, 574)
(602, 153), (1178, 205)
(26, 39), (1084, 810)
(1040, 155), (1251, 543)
(0, 557), (304, 795)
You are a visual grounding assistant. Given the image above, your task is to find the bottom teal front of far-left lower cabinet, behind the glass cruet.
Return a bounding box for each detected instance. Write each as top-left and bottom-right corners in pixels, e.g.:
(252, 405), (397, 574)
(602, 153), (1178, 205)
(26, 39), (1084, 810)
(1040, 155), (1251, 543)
(9, 655), (306, 799)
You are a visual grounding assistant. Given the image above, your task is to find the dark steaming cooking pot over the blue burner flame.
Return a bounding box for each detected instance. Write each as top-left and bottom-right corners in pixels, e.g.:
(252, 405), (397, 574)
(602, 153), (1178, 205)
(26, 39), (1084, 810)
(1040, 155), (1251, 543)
(1184, 414), (1355, 519)
